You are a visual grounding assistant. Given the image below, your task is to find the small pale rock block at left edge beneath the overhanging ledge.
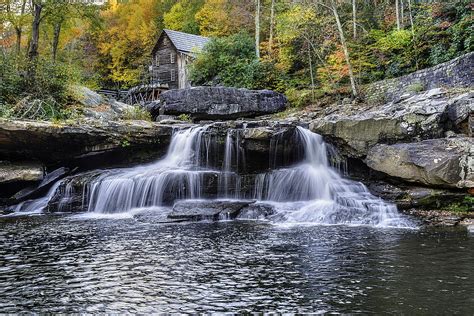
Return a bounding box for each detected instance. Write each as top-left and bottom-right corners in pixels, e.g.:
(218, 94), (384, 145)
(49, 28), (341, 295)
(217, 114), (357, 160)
(0, 161), (44, 184)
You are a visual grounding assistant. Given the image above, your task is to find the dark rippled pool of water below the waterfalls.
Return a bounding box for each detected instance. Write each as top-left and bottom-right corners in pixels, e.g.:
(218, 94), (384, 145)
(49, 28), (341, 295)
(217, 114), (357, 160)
(0, 213), (474, 314)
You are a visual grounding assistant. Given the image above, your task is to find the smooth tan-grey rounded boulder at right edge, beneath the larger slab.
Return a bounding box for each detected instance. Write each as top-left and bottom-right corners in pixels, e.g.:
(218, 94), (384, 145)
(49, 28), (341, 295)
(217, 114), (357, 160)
(366, 137), (474, 188)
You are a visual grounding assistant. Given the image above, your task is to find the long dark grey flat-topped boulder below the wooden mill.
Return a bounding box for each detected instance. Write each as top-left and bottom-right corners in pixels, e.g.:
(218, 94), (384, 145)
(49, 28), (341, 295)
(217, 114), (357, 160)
(157, 87), (287, 120)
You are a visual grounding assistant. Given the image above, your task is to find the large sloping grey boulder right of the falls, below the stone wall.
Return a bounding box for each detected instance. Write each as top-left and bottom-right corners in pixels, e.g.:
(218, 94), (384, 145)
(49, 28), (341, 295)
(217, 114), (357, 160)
(310, 89), (474, 158)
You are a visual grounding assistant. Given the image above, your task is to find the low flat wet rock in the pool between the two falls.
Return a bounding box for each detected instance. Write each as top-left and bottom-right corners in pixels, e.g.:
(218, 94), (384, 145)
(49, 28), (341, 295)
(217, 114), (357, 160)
(168, 200), (252, 221)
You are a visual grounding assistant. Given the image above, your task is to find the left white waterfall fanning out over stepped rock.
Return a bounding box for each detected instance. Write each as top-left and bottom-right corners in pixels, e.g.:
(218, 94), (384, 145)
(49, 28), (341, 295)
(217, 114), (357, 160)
(88, 126), (208, 213)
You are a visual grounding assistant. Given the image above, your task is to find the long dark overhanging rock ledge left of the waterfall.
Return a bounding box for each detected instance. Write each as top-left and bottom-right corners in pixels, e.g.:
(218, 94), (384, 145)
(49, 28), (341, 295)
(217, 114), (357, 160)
(0, 119), (173, 165)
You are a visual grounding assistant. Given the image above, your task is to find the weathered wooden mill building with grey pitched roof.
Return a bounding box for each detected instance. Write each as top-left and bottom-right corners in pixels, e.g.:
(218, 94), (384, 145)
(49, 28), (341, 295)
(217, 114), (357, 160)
(150, 29), (209, 89)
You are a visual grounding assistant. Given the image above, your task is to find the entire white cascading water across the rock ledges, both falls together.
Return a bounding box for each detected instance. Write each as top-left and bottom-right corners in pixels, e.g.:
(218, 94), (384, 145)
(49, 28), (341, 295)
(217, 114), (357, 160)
(10, 125), (412, 227)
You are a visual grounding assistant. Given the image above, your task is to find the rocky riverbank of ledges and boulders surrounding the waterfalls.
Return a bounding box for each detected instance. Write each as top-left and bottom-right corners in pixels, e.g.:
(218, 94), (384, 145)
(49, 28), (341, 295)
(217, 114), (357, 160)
(0, 80), (474, 226)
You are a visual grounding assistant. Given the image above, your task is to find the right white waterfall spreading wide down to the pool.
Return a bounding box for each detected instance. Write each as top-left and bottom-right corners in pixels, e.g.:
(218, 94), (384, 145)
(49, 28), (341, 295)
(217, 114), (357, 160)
(254, 127), (412, 227)
